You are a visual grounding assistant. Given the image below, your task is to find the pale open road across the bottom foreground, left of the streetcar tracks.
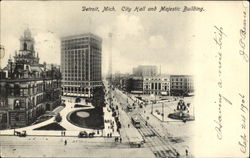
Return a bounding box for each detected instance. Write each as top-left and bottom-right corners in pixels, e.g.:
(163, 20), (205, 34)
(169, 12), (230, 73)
(0, 136), (153, 158)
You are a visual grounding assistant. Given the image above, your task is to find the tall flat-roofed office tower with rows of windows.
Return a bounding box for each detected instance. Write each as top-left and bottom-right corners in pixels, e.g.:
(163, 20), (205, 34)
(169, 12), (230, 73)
(61, 33), (102, 97)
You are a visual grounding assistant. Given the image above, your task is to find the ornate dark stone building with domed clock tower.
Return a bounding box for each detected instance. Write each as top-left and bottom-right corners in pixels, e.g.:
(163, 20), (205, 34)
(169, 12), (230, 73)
(0, 29), (61, 129)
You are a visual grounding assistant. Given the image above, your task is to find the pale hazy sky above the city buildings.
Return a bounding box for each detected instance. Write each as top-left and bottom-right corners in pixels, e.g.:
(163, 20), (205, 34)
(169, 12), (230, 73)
(1, 1), (196, 74)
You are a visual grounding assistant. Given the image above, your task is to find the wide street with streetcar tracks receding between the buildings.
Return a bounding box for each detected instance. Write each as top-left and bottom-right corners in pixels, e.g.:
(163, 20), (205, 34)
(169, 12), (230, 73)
(111, 89), (193, 157)
